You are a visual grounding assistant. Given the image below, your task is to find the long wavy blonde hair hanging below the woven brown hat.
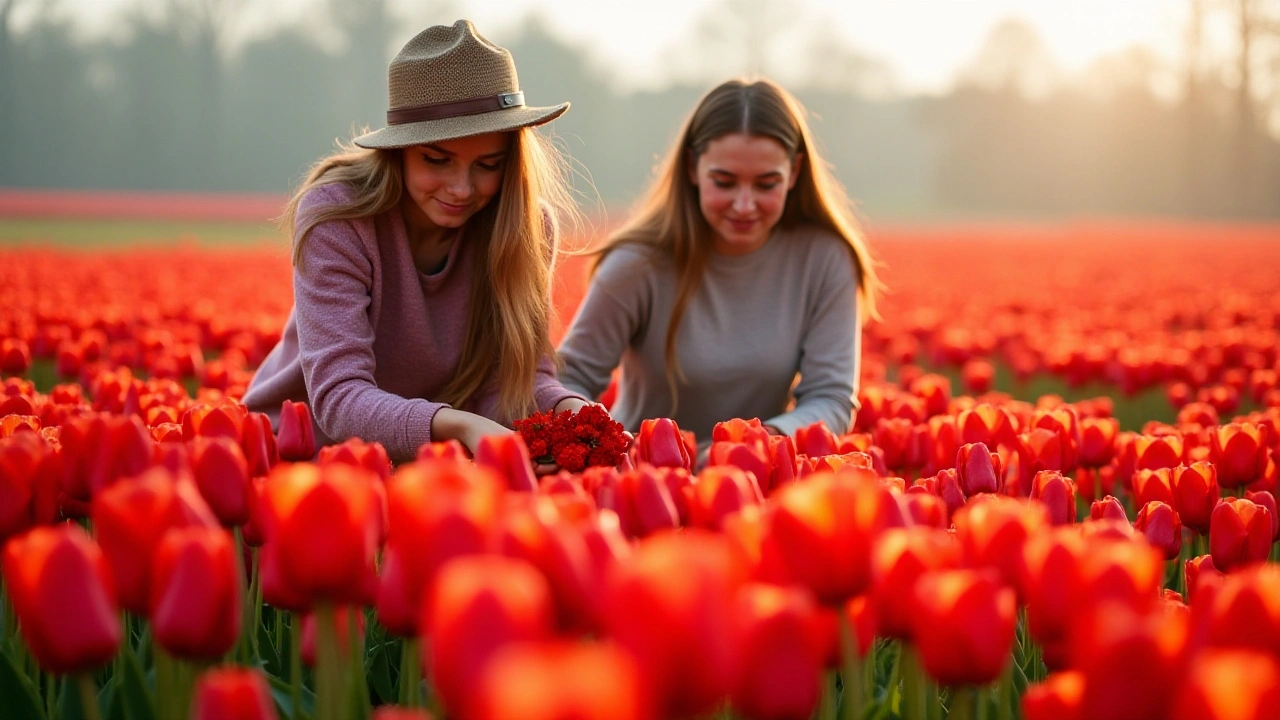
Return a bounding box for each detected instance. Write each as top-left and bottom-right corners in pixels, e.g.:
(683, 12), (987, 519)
(280, 128), (580, 420)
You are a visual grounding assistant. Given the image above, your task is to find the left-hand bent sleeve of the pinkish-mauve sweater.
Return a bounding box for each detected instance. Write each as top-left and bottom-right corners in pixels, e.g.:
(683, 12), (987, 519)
(293, 202), (448, 460)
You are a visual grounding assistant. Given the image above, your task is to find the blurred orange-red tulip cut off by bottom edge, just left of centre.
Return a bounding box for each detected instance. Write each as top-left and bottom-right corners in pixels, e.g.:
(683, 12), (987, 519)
(471, 642), (655, 720)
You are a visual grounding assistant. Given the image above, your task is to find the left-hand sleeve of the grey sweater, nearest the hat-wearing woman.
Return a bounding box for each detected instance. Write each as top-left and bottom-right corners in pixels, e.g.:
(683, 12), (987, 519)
(559, 247), (649, 398)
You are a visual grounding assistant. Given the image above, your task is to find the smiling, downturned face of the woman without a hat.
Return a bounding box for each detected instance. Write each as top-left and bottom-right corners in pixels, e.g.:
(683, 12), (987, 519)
(689, 133), (803, 255)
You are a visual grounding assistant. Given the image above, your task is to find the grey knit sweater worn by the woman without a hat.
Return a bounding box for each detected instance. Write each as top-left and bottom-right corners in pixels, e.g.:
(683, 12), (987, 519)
(559, 227), (861, 442)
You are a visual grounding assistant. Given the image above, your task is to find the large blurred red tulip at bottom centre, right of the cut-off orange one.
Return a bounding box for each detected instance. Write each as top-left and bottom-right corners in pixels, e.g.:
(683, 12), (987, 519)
(604, 527), (747, 717)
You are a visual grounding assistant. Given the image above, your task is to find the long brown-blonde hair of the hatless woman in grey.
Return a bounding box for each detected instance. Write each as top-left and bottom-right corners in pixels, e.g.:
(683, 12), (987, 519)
(595, 79), (883, 404)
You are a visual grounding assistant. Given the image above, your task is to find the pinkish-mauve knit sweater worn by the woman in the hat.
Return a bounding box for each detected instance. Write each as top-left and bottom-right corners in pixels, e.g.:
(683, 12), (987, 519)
(244, 183), (581, 461)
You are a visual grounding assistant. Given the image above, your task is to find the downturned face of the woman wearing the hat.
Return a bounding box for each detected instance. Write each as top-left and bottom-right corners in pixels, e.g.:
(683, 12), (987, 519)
(403, 132), (511, 235)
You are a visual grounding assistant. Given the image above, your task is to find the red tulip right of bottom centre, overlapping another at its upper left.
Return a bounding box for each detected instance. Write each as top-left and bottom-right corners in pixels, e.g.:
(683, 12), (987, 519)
(913, 570), (1018, 685)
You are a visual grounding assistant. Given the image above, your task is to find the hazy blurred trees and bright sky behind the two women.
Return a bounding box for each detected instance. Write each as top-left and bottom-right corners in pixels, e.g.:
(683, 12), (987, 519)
(0, 0), (1280, 222)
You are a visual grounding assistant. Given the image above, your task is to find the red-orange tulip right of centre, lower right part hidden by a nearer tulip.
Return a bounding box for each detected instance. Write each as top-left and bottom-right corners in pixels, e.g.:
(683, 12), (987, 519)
(869, 528), (960, 641)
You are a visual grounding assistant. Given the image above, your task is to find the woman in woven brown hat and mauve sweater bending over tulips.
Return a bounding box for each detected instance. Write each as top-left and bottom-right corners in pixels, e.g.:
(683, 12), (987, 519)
(244, 20), (585, 460)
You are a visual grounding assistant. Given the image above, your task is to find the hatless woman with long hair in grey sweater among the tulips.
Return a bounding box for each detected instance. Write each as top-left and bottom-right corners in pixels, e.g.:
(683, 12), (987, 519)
(559, 81), (881, 445)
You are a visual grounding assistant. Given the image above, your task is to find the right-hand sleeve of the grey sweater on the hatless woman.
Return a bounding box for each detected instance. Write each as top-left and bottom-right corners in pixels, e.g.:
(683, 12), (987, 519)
(764, 243), (861, 434)
